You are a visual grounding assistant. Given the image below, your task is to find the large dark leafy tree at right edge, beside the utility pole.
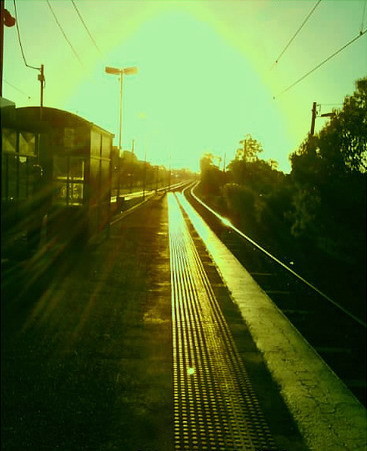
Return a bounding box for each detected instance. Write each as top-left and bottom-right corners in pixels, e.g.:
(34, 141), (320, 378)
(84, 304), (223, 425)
(291, 78), (367, 260)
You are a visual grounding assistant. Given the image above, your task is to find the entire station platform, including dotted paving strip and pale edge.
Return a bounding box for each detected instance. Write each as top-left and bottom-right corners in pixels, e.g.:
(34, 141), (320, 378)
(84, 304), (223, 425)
(2, 193), (367, 451)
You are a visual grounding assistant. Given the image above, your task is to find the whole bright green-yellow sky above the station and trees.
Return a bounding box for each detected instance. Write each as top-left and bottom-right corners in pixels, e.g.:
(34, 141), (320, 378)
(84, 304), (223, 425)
(3, 0), (367, 172)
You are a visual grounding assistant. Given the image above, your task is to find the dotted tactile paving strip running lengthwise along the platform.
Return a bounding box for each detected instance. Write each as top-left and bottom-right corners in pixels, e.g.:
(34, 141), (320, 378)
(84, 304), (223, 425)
(168, 193), (277, 451)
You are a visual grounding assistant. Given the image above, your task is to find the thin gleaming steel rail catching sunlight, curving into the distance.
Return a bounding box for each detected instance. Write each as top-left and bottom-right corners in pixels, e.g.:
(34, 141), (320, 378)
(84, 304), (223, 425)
(183, 182), (367, 328)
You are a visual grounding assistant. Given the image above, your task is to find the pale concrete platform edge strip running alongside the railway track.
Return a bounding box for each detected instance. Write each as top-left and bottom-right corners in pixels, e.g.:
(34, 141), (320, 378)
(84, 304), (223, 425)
(179, 196), (367, 451)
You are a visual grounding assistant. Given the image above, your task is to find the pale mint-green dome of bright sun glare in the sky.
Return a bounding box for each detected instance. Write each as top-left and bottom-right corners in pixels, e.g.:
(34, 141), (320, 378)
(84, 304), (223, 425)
(58, 7), (294, 171)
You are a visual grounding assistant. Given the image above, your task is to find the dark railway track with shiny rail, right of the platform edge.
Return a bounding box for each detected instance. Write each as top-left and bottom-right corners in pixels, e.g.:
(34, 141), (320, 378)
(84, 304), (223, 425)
(185, 182), (366, 405)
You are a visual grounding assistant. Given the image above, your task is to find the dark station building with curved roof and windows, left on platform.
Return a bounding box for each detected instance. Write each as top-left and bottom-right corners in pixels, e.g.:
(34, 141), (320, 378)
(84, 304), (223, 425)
(2, 102), (114, 251)
